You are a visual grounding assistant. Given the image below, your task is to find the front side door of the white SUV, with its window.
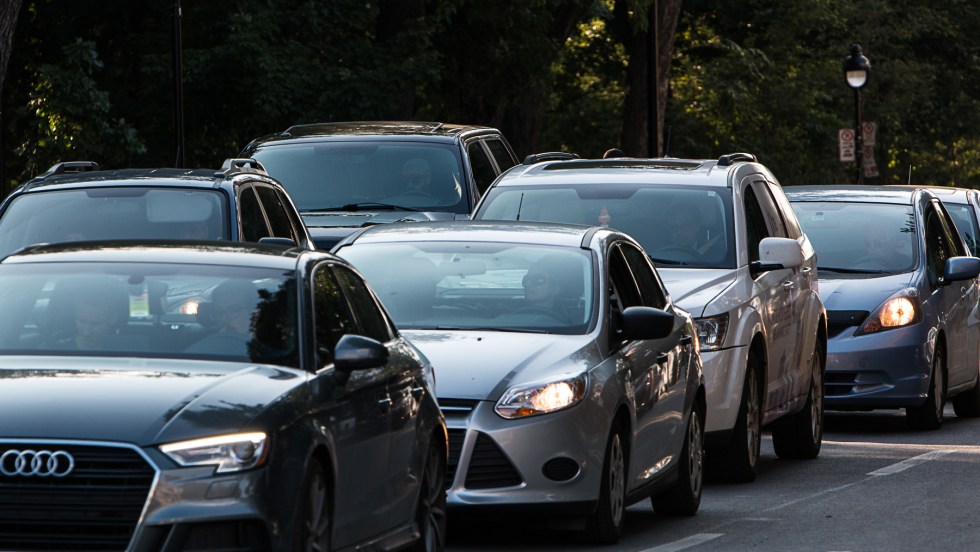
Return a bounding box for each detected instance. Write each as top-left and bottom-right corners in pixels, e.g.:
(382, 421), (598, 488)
(742, 181), (802, 412)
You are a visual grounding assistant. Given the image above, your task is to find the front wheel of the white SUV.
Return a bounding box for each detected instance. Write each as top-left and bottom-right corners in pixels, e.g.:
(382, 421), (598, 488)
(705, 354), (762, 483)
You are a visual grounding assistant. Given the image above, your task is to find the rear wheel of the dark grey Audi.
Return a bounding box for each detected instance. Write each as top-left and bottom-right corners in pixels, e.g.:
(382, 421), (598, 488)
(413, 439), (446, 552)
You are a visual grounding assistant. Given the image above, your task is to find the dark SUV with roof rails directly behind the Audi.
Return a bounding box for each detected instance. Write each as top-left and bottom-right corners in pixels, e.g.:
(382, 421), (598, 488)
(0, 159), (314, 258)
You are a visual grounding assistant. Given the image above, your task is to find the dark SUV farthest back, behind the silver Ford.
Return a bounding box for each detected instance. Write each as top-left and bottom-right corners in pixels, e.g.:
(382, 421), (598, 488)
(240, 121), (518, 249)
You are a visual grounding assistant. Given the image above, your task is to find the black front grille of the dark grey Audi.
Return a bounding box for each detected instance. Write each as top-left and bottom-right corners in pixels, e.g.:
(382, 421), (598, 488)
(0, 442), (155, 551)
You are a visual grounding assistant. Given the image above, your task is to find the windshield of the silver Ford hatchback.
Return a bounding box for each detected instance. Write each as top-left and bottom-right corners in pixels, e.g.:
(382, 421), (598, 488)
(338, 242), (595, 335)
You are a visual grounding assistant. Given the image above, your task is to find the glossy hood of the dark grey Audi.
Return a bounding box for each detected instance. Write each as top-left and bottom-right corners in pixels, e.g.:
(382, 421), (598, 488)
(0, 356), (306, 446)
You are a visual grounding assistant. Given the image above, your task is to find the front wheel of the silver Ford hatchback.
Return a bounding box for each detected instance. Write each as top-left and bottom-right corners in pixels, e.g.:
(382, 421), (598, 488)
(585, 423), (627, 544)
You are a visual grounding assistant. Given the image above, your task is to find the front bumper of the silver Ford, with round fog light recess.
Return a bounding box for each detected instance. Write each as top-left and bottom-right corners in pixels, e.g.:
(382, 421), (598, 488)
(440, 399), (609, 514)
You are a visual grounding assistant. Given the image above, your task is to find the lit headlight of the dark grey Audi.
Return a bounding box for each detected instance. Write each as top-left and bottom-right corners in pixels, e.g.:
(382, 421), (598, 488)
(160, 433), (266, 473)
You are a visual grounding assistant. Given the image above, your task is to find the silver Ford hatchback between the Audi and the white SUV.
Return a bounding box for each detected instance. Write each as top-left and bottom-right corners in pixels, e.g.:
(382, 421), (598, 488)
(334, 222), (705, 543)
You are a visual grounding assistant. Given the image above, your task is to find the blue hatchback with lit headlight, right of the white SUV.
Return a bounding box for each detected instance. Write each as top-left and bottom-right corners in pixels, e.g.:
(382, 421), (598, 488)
(786, 185), (980, 429)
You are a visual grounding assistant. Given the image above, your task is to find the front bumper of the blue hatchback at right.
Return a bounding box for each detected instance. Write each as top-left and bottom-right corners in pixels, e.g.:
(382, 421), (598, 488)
(824, 323), (935, 409)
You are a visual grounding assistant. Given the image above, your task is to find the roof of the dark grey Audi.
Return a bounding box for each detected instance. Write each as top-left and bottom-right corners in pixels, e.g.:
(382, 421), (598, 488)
(2, 240), (322, 269)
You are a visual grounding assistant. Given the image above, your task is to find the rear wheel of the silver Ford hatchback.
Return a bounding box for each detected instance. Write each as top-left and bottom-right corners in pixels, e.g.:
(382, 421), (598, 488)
(650, 408), (704, 516)
